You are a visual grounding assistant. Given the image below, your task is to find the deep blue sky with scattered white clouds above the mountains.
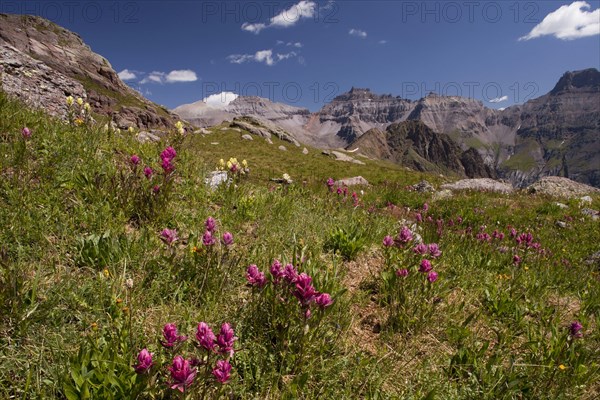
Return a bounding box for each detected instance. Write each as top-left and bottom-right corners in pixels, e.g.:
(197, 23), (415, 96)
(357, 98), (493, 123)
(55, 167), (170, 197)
(0, 0), (600, 110)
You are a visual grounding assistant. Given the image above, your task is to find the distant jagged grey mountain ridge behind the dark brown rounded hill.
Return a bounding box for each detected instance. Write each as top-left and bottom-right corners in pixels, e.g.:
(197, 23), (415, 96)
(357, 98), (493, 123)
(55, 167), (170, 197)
(175, 68), (600, 186)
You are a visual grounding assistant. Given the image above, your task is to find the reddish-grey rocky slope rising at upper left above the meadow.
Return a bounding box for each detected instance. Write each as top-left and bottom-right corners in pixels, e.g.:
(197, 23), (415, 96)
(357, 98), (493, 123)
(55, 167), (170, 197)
(0, 14), (177, 129)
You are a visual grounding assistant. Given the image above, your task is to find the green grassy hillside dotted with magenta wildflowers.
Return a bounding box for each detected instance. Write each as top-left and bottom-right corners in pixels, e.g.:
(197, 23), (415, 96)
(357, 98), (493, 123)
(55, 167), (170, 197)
(0, 93), (600, 399)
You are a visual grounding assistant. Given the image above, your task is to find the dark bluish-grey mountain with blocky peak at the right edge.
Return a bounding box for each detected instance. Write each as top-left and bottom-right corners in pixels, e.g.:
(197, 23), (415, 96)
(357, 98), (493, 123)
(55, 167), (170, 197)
(501, 69), (600, 187)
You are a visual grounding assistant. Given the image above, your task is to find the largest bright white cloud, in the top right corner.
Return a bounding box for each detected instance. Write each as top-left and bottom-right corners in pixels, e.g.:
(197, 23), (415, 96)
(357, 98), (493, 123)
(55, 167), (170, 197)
(519, 1), (600, 40)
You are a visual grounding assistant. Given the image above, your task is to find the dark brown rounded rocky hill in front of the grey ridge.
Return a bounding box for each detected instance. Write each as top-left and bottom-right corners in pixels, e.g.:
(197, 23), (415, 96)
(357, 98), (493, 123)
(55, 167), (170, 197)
(349, 121), (495, 178)
